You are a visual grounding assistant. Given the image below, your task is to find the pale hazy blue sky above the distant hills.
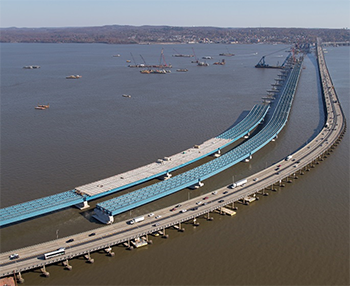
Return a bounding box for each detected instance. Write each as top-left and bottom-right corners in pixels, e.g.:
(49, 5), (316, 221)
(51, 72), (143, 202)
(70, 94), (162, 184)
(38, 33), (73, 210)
(0, 0), (350, 28)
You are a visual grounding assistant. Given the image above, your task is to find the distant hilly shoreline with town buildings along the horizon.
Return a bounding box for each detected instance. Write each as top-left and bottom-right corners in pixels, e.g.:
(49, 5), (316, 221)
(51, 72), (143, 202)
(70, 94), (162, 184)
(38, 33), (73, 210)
(0, 25), (350, 44)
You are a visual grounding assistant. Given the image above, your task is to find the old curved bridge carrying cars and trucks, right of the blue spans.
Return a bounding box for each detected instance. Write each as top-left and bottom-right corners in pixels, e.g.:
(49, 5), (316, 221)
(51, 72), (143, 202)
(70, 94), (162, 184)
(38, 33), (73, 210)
(0, 40), (346, 282)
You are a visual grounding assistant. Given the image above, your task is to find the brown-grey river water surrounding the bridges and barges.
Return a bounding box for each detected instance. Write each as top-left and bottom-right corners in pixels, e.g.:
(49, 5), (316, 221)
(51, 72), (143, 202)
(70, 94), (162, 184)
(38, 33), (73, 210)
(0, 43), (350, 286)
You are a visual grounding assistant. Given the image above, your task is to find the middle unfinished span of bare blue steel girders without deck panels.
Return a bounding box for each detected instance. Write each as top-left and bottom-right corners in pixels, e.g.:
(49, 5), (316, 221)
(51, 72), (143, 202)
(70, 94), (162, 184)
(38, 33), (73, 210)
(95, 56), (302, 223)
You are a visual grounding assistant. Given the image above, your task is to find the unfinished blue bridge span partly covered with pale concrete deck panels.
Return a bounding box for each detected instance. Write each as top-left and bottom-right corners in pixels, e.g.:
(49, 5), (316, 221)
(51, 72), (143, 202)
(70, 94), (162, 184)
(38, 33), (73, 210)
(0, 98), (270, 226)
